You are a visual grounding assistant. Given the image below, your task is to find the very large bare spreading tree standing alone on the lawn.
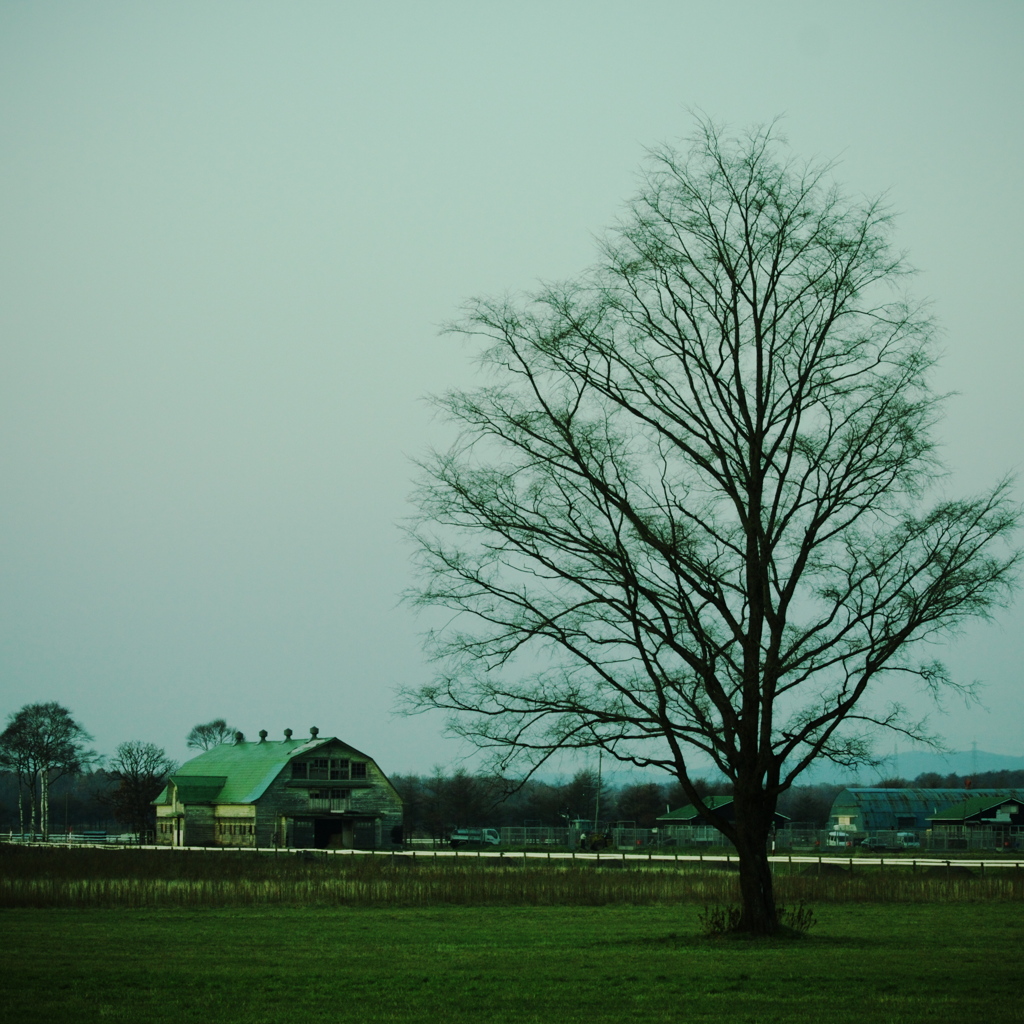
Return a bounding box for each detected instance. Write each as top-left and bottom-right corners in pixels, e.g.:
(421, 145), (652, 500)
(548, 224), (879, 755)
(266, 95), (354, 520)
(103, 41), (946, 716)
(411, 121), (1018, 934)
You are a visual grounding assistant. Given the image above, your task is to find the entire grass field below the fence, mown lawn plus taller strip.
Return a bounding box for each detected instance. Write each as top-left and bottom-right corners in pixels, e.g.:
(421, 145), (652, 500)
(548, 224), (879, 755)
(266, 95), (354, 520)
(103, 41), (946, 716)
(6, 846), (1024, 1024)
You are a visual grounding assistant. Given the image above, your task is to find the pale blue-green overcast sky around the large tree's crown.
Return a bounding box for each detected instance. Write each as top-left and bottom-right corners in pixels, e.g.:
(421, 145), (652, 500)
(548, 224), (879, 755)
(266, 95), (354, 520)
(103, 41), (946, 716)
(0, 0), (1024, 772)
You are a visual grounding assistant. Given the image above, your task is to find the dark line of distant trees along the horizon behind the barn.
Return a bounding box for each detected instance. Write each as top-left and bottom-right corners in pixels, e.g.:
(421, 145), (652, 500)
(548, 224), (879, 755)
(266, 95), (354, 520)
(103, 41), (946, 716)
(6, 701), (1024, 839)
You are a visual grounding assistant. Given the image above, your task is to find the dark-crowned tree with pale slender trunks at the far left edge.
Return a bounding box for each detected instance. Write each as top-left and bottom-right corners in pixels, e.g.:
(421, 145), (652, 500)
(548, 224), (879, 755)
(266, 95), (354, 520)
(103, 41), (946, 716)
(0, 700), (95, 840)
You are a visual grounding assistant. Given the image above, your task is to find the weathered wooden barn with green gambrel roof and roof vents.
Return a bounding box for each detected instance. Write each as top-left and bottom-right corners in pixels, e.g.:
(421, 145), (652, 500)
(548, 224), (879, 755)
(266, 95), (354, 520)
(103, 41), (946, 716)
(154, 729), (402, 850)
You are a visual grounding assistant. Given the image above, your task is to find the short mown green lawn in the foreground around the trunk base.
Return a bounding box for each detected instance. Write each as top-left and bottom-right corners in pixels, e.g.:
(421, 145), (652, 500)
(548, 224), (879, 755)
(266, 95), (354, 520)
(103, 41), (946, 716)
(0, 902), (1024, 1024)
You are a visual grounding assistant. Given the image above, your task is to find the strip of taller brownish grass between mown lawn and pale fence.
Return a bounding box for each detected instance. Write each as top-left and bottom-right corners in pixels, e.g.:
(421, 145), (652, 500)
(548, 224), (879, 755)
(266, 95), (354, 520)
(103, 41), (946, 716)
(0, 846), (1024, 909)
